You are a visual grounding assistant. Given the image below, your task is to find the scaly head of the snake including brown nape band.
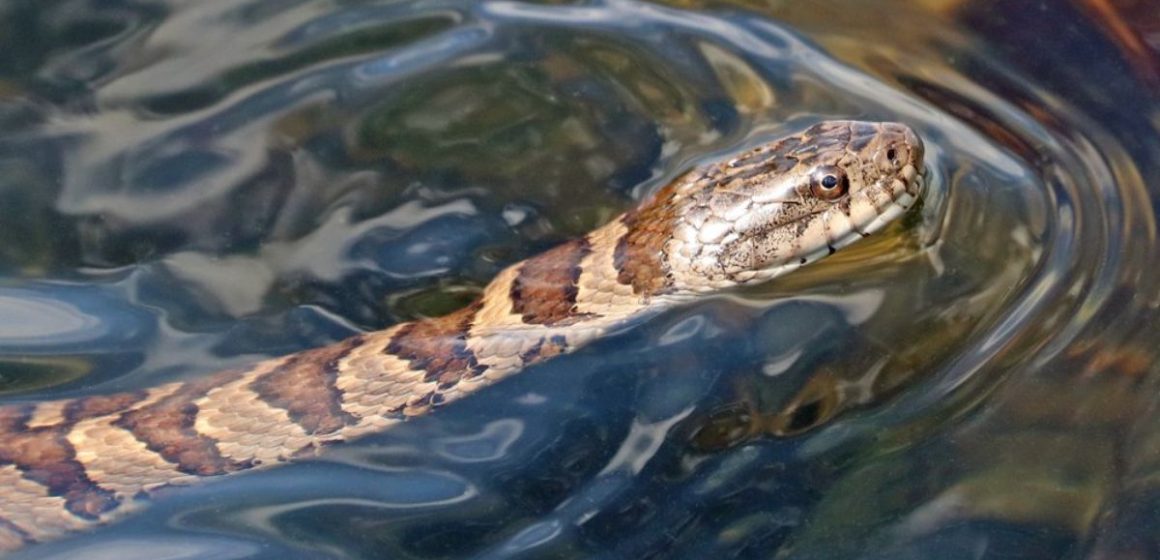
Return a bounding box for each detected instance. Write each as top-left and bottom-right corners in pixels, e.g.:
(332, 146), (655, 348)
(625, 121), (925, 294)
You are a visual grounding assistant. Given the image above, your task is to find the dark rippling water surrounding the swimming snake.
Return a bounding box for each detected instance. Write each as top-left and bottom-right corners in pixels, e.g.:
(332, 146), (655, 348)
(0, 0), (1160, 559)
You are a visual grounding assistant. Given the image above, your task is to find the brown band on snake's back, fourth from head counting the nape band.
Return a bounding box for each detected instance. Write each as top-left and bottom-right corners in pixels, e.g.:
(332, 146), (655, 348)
(251, 336), (364, 435)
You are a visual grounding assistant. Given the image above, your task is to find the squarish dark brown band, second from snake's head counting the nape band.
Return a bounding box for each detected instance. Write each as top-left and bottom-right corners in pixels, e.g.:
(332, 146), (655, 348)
(510, 238), (590, 326)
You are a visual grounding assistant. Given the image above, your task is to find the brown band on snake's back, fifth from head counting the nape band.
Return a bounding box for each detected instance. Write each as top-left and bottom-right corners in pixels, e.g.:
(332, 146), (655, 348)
(114, 370), (253, 477)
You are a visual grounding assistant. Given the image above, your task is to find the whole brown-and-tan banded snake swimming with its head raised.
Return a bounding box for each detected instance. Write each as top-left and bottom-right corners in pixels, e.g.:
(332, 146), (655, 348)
(0, 122), (923, 551)
